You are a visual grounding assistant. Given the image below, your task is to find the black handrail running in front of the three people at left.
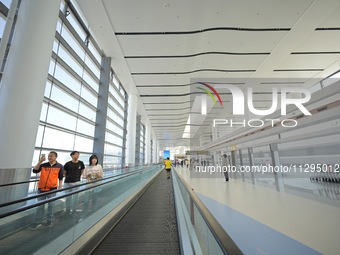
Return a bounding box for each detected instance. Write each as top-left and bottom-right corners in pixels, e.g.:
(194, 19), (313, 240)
(0, 168), (161, 219)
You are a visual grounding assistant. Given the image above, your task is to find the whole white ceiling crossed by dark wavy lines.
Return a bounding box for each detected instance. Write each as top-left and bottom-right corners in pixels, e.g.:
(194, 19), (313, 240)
(75, 0), (340, 148)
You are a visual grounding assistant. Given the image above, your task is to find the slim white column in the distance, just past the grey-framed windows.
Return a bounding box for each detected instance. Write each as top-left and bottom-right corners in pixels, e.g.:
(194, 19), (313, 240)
(126, 95), (137, 165)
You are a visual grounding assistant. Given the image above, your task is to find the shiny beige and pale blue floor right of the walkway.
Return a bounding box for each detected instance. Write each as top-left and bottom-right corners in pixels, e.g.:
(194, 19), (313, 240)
(177, 168), (340, 254)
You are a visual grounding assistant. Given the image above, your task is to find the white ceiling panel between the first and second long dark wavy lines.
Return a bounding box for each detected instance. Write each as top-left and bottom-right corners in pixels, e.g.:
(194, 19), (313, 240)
(117, 31), (288, 57)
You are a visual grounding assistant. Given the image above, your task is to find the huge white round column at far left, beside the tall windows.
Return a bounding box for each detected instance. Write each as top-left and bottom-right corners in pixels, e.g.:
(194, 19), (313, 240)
(0, 0), (61, 203)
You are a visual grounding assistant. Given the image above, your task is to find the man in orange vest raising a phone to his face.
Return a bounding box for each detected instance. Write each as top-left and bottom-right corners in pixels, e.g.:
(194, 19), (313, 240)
(31, 151), (64, 229)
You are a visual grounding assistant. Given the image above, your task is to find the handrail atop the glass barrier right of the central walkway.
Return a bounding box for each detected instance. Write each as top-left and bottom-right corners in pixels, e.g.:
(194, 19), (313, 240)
(175, 171), (243, 255)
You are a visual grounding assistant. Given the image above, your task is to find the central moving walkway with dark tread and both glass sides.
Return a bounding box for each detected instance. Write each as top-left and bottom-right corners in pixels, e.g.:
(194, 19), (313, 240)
(0, 165), (242, 255)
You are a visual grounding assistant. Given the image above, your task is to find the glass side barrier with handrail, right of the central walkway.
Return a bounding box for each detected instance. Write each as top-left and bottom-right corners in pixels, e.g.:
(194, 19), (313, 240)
(173, 167), (243, 255)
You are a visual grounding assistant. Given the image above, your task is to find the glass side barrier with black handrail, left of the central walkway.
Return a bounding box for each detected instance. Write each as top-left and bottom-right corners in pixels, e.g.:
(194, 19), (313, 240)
(0, 165), (161, 254)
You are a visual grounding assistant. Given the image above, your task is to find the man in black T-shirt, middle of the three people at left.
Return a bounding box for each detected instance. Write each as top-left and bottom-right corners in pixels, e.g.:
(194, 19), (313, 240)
(64, 151), (85, 214)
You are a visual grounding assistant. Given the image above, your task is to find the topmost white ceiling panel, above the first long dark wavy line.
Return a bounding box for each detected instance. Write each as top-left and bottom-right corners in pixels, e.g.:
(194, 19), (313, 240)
(103, 0), (314, 32)
